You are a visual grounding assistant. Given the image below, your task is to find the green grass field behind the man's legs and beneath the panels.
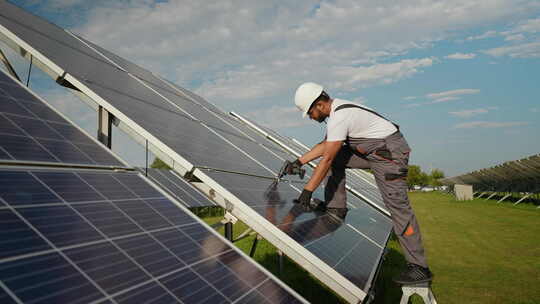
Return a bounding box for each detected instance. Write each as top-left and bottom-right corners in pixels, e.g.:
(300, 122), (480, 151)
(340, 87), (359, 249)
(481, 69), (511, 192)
(200, 192), (540, 304)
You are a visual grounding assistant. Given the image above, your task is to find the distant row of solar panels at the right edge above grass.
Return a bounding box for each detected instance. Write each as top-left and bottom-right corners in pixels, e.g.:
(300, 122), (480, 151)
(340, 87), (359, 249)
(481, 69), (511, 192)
(441, 154), (540, 193)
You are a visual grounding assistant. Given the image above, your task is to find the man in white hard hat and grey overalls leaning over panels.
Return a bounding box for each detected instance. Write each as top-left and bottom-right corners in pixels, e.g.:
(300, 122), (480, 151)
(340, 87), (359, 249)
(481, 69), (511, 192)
(286, 82), (433, 284)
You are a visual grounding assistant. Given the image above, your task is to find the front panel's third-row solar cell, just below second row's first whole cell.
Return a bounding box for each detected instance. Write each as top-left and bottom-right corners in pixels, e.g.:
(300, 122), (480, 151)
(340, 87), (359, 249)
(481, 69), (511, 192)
(64, 242), (150, 294)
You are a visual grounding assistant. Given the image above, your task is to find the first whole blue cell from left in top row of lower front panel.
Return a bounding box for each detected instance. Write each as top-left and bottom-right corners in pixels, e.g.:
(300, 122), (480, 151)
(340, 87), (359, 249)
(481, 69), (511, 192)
(34, 172), (105, 202)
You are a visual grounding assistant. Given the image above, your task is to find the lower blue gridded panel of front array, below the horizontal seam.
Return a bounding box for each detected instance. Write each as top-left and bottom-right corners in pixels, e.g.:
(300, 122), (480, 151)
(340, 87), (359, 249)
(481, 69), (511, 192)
(0, 169), (300, 303)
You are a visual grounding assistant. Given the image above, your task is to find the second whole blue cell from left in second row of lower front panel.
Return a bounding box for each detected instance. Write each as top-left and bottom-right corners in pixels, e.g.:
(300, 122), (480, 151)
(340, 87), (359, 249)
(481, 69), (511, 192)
(72, 202), (142, 238)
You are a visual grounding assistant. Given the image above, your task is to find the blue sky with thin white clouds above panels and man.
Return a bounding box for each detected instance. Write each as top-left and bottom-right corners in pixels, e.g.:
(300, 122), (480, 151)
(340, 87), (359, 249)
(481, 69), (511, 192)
(0, 0), (540, 176)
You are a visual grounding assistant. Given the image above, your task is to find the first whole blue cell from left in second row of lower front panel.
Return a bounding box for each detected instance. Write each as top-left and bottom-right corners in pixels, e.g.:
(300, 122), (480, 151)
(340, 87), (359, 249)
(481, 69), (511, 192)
(18, 206), (103, 247)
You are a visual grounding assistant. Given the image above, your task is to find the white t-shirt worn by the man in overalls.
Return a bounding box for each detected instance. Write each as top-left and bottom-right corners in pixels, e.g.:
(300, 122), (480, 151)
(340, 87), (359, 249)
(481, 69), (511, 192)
(326, 98), (397, 141)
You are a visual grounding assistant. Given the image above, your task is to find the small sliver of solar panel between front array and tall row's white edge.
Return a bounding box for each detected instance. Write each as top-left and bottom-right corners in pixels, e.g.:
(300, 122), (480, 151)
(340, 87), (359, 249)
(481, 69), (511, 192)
(141, 168), (216, 207)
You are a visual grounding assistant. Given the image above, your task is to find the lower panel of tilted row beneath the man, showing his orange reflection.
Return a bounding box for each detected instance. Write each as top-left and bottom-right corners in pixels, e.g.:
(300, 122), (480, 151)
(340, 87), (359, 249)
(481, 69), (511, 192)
(207, 172), (392, 291)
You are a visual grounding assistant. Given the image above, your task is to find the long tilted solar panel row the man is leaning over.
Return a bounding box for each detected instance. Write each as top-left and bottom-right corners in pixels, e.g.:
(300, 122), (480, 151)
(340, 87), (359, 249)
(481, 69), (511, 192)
(0, 1), (392, 303)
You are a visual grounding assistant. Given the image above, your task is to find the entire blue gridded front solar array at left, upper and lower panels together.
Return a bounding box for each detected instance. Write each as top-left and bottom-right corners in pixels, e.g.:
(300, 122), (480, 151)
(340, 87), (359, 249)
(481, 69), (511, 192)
(0, 67), (305, 303)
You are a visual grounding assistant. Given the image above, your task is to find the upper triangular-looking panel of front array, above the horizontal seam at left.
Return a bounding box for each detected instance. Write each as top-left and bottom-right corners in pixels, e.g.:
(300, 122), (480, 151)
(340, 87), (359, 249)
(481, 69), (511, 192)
(0, 72), (124, 167)
